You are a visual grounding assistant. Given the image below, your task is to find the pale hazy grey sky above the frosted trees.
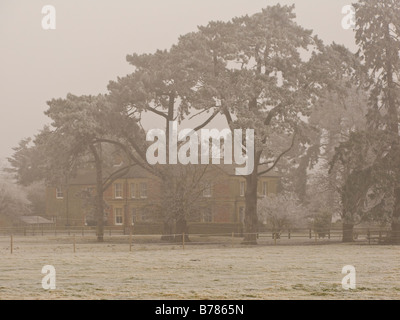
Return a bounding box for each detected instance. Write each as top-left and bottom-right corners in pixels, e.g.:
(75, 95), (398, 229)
(0, 0), (355, 159)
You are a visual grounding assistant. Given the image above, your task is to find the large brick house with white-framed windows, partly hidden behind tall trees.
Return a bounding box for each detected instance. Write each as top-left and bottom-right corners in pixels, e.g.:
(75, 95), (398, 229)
(46, 164), (279, 232)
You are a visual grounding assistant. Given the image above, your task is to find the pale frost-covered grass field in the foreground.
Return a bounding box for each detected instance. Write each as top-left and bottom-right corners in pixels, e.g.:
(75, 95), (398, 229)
(0, 236), (400, 300)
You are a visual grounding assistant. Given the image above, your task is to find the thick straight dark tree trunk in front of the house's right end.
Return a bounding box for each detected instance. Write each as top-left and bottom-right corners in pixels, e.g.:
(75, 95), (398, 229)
(243, 151), (261, 245)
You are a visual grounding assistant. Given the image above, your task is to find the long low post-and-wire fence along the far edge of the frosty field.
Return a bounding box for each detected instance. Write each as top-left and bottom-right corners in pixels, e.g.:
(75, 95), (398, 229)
(0, 226), (392, 253)
